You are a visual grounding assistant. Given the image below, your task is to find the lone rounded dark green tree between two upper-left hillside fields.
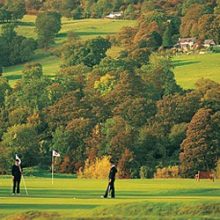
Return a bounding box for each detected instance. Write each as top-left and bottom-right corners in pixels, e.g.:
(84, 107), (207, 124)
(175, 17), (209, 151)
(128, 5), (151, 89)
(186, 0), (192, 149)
(35, 12), (61, 48)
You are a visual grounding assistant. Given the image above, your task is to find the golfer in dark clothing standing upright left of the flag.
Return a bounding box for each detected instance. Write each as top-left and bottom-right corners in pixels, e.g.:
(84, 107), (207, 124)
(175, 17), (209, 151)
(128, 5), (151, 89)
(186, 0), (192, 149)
(11, 159), (22, 195)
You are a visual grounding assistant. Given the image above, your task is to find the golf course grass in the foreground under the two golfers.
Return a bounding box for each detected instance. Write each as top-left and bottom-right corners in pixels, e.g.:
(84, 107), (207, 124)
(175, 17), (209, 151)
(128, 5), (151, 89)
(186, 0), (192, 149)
(0, 176), (220, 220)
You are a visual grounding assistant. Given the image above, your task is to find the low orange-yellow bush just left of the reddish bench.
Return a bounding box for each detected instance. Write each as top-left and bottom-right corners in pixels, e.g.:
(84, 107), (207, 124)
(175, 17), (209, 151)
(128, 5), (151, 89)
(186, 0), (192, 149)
(154, 166), (179, 178)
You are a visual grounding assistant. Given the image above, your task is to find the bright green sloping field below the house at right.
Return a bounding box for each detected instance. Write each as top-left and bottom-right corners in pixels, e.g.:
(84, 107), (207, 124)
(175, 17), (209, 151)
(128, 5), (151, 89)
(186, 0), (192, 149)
(173, 54), (220, 89)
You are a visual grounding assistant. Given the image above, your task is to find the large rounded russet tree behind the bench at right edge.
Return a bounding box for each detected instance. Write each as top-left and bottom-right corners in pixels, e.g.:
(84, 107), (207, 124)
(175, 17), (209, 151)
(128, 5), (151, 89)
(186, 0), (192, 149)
(180, 108), (219, 177)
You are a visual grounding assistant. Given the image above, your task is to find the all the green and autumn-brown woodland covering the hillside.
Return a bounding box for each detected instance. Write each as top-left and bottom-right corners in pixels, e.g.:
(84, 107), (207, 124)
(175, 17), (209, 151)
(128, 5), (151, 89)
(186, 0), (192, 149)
(0, 0), (220, 178)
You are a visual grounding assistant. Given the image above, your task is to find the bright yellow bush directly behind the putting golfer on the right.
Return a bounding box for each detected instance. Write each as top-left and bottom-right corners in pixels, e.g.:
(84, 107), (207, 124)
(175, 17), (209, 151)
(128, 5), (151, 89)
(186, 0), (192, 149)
(77, 156), (111, 179)
